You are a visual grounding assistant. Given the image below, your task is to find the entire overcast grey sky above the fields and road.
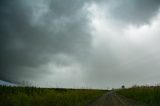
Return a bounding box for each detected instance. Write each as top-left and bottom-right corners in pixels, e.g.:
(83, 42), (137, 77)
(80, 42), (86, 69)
(0, 0), (160, 88)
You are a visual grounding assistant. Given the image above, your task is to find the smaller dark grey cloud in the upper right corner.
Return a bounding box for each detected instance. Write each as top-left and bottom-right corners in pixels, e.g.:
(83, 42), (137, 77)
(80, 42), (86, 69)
(97, 0), (160, 24)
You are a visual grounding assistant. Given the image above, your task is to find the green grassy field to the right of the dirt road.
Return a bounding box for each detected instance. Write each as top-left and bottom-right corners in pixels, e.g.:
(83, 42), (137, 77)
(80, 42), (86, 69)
(117, 86), (160, 106)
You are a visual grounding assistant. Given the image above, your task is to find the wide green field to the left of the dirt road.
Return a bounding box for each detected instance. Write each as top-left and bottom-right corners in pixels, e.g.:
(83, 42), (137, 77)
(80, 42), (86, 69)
(0, 86), (106, 106)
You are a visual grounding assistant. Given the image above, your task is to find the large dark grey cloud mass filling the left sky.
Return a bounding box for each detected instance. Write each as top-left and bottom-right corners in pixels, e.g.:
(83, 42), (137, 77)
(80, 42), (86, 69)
(0, 0), (91, 82)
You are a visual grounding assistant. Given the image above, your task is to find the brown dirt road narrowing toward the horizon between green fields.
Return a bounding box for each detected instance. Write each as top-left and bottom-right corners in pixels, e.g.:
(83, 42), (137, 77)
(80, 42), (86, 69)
(88, 91), (146, 106)
